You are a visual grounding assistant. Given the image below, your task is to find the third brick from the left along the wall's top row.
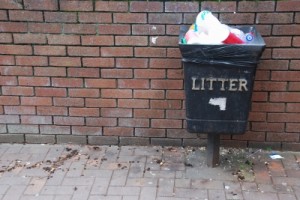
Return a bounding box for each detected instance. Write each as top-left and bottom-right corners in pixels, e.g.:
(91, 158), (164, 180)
(60, 0), (93, 11)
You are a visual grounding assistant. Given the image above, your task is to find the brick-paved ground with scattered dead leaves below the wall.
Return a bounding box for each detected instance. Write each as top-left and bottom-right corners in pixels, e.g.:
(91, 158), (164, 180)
(0, 144), (300, 200)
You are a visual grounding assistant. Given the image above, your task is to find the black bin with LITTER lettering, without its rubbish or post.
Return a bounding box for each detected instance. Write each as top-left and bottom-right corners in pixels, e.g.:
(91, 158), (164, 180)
(179, 26), (265, 134)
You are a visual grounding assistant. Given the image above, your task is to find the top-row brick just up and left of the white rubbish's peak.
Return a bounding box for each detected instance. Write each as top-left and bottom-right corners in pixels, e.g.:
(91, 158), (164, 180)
(165, 2), (199, 13)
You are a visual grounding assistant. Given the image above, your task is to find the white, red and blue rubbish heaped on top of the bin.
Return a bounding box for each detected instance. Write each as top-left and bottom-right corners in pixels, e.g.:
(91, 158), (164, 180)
(181, 10), (255, 45)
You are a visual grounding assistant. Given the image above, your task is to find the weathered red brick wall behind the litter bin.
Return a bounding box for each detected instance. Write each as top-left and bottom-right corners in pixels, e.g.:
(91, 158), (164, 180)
(0, 0), (300, 150)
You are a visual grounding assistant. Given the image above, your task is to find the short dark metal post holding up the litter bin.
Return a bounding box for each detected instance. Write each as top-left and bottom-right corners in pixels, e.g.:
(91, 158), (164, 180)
(206, 134), (220, 167)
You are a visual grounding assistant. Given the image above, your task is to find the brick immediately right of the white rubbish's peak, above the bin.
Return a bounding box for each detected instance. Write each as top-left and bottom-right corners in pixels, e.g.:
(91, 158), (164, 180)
(219, 13), (255, 24)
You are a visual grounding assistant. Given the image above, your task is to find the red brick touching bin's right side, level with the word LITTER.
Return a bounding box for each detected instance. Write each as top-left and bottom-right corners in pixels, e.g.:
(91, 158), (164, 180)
(254, 81), (287, 91)
